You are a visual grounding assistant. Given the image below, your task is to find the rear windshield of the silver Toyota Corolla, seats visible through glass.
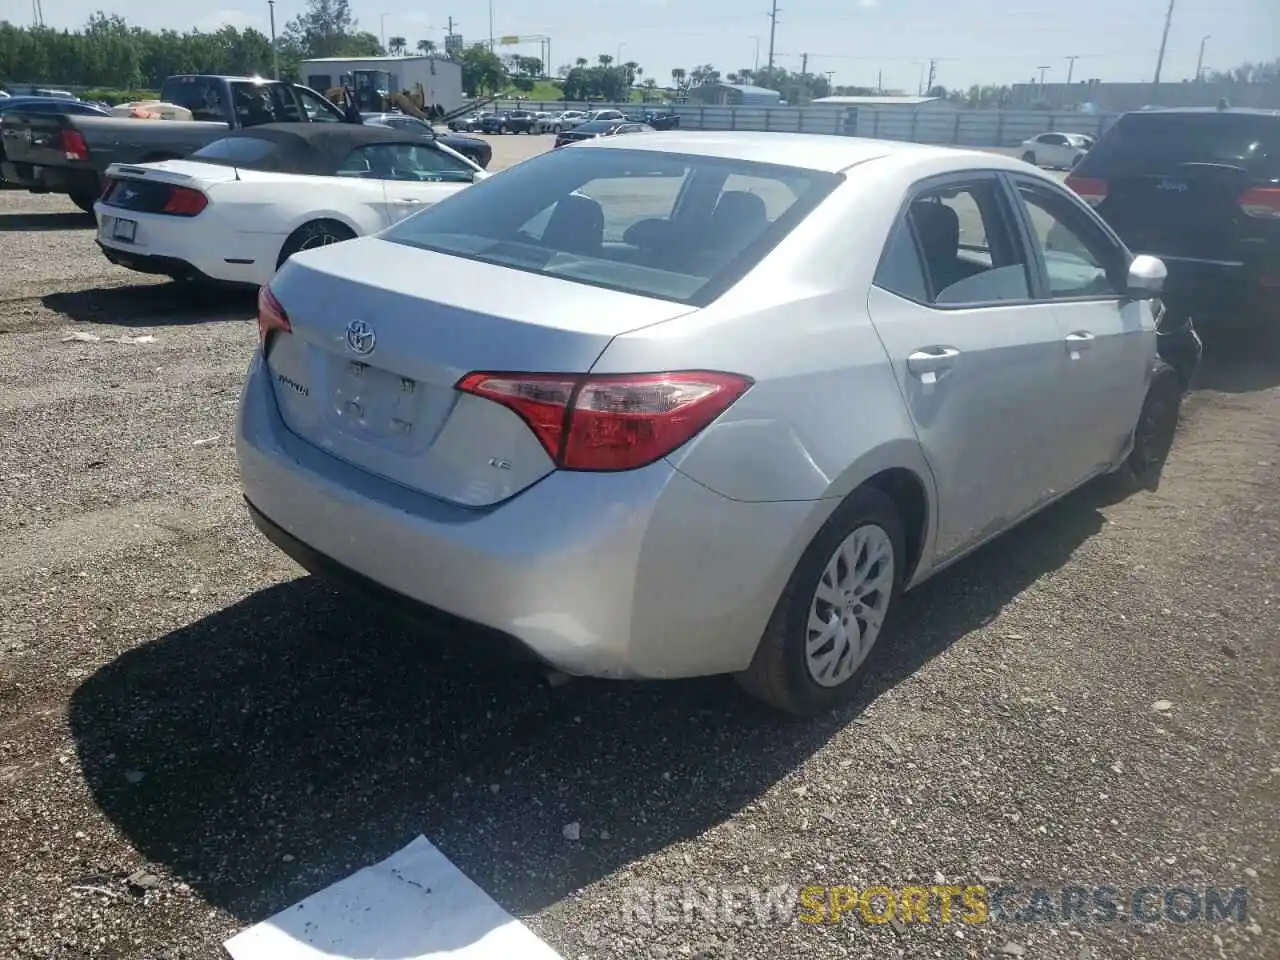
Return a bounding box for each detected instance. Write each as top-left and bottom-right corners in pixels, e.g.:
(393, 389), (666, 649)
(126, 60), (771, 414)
(381, 147), (841, 306)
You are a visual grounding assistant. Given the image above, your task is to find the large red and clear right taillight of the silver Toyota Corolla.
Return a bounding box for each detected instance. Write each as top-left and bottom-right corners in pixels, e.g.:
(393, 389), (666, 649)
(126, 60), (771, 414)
(457, 370), (753, 471)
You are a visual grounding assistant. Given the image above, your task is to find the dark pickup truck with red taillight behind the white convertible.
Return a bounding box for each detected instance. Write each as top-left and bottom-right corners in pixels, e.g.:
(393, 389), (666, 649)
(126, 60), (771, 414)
(0, 74), (488, 212)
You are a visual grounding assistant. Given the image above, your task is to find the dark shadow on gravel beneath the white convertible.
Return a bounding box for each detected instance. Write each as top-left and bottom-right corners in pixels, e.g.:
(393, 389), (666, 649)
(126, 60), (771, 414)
(41, 280), (257, 326)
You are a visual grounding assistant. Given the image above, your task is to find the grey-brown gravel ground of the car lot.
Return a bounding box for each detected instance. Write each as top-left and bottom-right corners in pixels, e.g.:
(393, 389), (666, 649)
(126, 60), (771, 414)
(0, 131), (1280, 960)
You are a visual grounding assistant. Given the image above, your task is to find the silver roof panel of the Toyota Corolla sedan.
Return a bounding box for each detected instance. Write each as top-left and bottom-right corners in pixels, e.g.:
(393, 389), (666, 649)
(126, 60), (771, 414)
(582, 131), (1027, 173)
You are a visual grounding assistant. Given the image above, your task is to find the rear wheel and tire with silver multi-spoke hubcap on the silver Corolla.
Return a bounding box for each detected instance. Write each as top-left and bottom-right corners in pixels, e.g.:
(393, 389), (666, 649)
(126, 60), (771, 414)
(735, 486), (906, 718)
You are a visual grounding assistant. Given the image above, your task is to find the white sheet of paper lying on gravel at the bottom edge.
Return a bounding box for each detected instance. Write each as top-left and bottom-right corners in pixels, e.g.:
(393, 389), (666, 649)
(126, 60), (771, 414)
(224, 837), (561, 960)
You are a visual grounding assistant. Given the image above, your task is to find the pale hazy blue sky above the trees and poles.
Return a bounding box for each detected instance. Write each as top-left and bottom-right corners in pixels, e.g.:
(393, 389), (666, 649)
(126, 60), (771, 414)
(20, 0), (1280, 92)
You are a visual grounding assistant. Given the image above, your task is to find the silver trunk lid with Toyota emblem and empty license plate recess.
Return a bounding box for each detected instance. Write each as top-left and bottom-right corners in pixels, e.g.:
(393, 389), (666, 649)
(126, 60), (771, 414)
(266, 238), (690, 507)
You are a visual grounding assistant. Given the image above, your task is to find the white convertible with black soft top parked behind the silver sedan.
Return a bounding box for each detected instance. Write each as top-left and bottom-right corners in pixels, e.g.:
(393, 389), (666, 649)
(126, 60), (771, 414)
(93, 123), (489, 285)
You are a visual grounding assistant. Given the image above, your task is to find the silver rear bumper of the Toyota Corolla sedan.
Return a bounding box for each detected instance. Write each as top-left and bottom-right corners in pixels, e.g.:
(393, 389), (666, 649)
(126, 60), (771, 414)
(237, 352), (819, 678)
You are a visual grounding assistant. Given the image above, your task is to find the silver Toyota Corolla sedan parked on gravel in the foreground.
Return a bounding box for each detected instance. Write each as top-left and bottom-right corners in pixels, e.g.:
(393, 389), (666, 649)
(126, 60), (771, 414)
(237, 132), (1181, 714)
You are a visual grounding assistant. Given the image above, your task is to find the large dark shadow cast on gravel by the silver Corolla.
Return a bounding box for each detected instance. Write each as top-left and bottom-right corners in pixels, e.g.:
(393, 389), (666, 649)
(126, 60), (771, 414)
(69, 489), (1103, 948)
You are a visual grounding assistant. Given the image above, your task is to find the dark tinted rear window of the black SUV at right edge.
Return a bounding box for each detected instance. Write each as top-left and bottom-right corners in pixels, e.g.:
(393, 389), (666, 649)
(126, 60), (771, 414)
(1080, 113), (1280, 177)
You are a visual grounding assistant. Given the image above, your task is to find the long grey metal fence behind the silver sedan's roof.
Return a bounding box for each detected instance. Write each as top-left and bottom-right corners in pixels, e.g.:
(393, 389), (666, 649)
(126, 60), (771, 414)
(498, 101), (1117, 147)
